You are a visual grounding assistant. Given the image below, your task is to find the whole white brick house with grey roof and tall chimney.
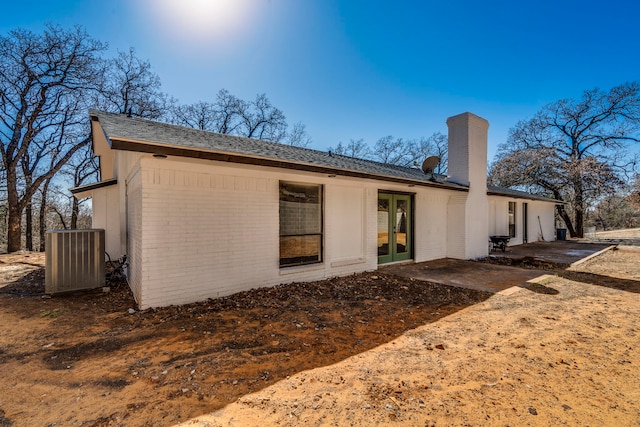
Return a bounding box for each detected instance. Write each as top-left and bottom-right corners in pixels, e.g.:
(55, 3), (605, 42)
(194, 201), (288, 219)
(73, 111), (555, 309)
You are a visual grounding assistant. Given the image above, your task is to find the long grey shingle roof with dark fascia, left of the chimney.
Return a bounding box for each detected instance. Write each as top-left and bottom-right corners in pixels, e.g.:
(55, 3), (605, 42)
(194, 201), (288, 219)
(90, 110), (468, 191)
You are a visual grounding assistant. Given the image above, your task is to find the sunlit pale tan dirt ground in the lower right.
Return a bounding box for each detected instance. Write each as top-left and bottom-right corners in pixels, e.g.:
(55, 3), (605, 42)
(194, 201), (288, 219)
(185, 247), (640, 426)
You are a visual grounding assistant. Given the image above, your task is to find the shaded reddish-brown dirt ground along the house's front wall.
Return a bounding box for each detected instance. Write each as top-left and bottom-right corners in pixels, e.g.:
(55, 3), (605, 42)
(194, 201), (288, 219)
(0, 253), (490, 426)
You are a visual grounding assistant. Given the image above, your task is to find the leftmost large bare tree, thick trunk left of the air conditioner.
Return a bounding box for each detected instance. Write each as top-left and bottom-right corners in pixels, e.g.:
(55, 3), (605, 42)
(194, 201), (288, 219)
(0, 26), (105, 252)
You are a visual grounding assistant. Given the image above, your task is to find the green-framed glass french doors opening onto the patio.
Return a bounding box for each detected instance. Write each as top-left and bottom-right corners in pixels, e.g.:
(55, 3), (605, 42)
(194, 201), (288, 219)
(378, 193), (413, 264)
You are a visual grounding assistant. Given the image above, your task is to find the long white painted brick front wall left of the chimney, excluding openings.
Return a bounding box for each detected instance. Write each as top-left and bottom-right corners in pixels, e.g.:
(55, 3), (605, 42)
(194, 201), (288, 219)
(121, 156), (465, 308)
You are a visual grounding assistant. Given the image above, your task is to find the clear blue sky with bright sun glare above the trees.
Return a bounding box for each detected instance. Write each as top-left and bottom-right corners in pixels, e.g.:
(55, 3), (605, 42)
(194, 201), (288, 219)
(0, 0), (640, 160)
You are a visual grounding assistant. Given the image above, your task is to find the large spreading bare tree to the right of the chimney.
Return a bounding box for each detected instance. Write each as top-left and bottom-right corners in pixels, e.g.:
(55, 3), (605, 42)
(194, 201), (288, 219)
(490, 82), (640, 237)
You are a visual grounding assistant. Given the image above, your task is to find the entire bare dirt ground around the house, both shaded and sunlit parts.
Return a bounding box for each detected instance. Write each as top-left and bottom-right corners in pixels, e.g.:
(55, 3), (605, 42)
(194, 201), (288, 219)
(0, 247), (640, 426)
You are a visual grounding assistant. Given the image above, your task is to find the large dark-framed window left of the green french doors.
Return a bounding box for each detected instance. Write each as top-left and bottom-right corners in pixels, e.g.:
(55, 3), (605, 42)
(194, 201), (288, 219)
(280, 181), (322, 267)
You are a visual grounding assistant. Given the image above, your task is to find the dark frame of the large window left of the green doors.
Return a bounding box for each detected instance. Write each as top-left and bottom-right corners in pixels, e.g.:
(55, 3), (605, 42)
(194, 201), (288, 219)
(278, 180), (325, 268)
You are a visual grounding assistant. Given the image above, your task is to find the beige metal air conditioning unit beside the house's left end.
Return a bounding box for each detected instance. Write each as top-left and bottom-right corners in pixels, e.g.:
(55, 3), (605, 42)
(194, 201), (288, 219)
(44, 230), (105, 294)
